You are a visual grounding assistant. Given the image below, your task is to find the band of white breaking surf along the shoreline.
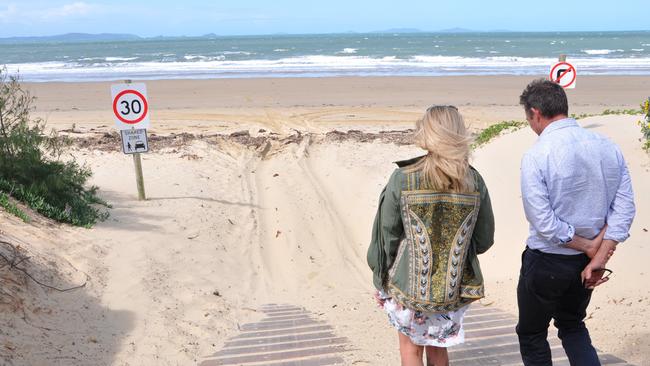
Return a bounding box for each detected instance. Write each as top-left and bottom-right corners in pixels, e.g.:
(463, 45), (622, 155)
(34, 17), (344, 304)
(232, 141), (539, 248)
(7, 54), (650, 81)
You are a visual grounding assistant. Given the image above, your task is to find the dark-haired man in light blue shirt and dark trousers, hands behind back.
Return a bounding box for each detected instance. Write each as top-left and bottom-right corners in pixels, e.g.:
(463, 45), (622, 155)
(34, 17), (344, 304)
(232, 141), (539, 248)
(517, 80), (635, 366)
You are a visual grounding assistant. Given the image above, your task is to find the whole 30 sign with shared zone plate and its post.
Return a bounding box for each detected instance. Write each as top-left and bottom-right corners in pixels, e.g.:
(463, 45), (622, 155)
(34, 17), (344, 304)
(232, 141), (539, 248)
(111, 80), (149, 201)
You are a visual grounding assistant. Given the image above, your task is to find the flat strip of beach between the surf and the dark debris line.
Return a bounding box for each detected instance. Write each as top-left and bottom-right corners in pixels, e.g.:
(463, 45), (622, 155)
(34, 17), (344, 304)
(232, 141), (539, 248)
(25, 75), (650, 134)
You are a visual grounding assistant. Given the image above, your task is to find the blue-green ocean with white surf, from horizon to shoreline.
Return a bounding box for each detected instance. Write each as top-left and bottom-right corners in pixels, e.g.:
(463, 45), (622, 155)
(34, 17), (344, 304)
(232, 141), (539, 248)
(0, 31), (650, 82)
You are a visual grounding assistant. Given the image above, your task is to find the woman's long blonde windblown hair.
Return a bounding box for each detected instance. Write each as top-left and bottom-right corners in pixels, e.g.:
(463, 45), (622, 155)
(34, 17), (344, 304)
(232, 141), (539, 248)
(406, 106), (475, 193)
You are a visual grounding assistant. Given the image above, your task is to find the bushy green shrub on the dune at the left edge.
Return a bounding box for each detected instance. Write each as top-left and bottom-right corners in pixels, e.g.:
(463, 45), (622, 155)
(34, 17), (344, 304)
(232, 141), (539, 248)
(0, 68), (108, 227)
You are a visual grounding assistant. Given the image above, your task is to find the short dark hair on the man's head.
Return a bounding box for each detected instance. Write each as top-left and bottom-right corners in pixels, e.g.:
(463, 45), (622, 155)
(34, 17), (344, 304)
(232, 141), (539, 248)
(519, 79), (569, 118)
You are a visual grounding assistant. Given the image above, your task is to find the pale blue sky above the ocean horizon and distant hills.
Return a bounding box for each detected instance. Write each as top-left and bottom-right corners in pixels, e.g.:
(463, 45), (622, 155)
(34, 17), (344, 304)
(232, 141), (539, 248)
(0, 0), (650, 37)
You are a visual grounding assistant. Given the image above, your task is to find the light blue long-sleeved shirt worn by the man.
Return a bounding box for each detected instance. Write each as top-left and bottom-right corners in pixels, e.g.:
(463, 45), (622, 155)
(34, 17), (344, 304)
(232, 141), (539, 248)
(521, 118), (635, 255)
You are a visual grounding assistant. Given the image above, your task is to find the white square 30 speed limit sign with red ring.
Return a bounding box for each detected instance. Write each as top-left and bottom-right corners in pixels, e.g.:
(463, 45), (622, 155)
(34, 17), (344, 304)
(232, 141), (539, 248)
(111, 83), (149, 130)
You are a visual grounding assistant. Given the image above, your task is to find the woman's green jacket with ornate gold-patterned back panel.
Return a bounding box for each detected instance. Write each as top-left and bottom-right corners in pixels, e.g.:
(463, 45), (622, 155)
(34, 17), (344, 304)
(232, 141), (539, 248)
(367, 157), (494, 313)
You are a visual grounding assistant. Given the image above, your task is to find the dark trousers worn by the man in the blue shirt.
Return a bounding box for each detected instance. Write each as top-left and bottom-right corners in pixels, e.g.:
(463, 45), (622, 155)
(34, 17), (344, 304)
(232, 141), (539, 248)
(517, 248), (600, 366)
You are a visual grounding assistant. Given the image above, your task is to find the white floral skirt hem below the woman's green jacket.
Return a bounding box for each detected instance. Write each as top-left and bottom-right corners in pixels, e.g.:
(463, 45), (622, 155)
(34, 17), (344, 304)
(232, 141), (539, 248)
(384, 298), (469, 347)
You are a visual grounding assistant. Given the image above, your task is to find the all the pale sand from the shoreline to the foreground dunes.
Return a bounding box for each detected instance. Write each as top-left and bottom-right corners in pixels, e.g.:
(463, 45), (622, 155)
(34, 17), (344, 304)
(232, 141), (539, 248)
(0, 76), (650, 365)
